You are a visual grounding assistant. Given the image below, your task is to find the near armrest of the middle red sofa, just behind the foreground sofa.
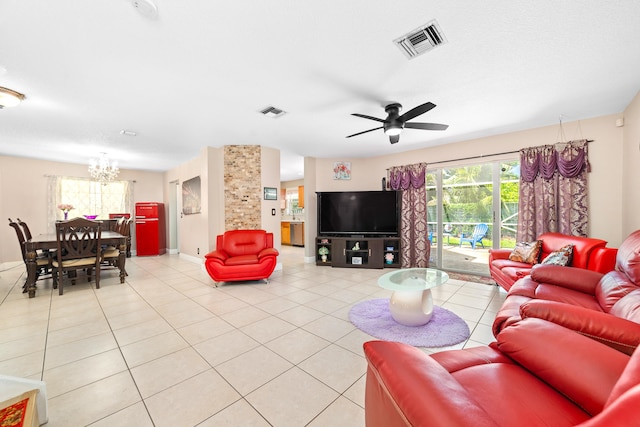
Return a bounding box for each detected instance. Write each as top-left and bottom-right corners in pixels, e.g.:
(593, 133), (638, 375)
(520, 300), (640, 354)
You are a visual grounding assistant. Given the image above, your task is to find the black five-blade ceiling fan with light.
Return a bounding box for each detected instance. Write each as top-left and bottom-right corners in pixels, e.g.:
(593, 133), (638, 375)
(347, 102), (449, 144)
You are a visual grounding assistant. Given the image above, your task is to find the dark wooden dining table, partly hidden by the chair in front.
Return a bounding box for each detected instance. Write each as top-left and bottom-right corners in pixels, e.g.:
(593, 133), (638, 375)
(24, 230), (127, 298)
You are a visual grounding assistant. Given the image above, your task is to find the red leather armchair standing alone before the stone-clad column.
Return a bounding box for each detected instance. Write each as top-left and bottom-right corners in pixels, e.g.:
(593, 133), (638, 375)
(204, 230), (278, 282)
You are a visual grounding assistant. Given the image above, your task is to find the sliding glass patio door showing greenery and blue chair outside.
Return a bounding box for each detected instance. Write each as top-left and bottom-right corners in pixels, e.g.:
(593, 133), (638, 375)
(427, 160), (520, 276)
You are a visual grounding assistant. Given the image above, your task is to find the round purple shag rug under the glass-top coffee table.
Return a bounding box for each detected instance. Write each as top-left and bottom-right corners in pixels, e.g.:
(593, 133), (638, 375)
(349, 298), (470, 347)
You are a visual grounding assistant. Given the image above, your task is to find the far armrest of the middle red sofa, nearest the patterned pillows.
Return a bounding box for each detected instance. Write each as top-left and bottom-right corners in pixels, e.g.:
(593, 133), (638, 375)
(531, 264), (603, 295)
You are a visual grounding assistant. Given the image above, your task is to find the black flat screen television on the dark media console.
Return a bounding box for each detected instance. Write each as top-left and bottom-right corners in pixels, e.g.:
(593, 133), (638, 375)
(317, 191), (401, 237)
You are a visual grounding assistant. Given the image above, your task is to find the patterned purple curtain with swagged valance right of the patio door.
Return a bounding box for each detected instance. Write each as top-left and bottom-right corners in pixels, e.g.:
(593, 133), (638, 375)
(517, 139), (589, 242)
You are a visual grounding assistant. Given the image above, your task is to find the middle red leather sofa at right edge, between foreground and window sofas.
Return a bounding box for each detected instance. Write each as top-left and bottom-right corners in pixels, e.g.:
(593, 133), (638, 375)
(493, 230), (640, 354)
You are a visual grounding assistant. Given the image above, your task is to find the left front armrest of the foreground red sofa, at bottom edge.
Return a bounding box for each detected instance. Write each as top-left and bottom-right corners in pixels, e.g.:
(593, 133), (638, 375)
(364, 341), (497, 427)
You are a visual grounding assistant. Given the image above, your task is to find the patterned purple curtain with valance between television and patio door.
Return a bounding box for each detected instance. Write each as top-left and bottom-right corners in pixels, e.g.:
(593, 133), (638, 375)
(389, 163), (431, 268)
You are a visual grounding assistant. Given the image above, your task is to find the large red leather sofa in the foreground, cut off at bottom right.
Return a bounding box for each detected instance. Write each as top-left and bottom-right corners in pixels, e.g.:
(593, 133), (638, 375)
(364, 319), (640, 427)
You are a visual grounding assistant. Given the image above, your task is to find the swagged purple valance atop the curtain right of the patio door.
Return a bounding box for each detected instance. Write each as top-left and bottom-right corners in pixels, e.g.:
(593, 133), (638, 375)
(520, 139), (589, 182)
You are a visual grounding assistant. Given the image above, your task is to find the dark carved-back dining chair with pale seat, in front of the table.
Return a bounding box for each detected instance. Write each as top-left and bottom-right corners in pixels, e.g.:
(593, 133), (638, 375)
(52, 217), (102, 295)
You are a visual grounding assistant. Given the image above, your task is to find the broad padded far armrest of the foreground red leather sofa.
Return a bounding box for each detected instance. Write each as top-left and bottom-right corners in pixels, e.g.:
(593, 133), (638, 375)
(497, 318), (629, 415)
